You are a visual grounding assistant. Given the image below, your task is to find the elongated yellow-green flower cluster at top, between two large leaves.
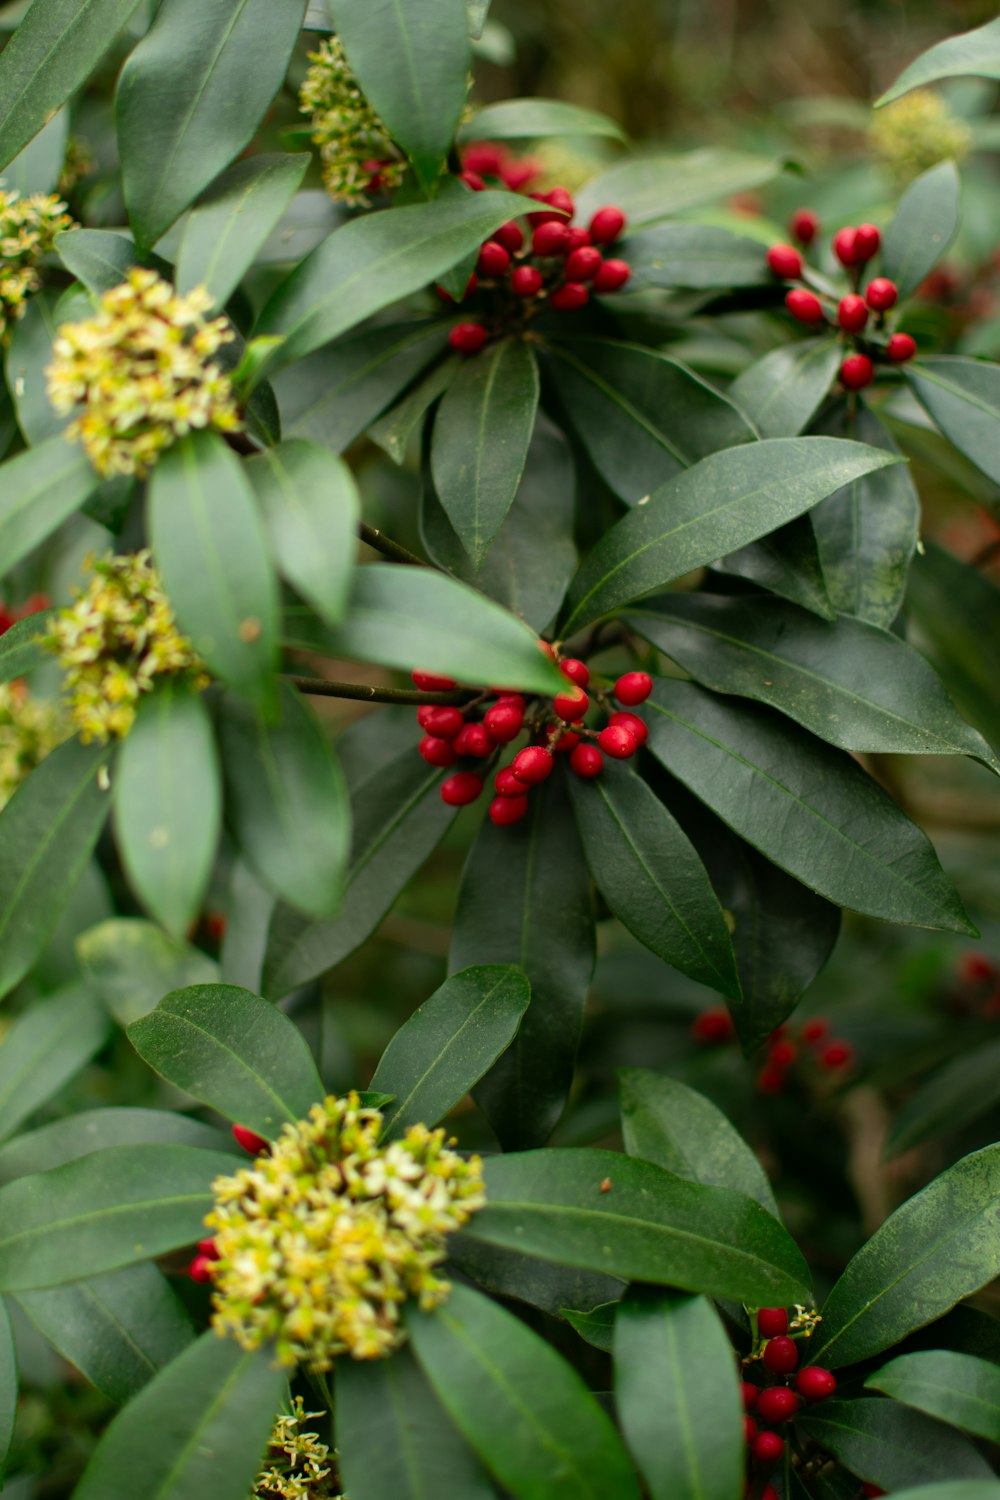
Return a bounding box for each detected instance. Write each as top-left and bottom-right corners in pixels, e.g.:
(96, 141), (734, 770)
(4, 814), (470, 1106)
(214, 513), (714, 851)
(298, 36), (406, 207)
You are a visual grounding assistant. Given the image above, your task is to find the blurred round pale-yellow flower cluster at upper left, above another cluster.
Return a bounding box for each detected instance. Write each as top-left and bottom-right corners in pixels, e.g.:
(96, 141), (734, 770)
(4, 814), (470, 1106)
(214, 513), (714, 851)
(46, 267), (240, 477)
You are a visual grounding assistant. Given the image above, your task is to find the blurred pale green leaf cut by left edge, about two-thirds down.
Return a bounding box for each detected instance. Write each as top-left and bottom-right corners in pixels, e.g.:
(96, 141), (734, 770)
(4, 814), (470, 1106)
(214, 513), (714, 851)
(0, 984), (111, 1140)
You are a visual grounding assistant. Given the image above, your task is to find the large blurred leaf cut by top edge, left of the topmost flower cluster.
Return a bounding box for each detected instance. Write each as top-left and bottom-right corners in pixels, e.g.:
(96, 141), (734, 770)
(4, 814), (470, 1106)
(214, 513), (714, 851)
(115, 0), (306, 249)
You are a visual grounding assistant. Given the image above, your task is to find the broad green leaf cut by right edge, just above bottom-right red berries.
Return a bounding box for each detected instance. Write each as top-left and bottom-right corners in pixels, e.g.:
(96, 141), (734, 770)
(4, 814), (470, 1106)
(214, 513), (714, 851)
(810, 1146), (1000, 1370)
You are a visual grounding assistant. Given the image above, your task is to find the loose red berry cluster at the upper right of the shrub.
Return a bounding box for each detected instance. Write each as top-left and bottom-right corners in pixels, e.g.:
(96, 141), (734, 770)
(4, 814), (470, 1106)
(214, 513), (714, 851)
(768, 209), (916, 390)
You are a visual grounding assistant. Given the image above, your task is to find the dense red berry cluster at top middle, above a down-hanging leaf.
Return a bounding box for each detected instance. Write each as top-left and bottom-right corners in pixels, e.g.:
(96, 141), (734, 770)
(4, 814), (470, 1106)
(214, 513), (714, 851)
(438, 174), (631, 354)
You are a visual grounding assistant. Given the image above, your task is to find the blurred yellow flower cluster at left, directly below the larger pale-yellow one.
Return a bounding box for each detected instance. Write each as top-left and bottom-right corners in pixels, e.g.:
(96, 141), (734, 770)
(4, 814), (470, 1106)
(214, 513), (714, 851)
(42, 548), (208, 744)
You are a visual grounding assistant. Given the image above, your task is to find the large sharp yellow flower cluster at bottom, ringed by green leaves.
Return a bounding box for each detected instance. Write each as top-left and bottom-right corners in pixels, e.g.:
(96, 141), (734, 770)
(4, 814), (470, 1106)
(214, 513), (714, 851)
(205, 1094), (486, 1371)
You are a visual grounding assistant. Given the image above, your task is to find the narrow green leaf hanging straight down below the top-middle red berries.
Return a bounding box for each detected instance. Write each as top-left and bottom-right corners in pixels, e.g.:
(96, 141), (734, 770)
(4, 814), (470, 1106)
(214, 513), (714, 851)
(430, 339), (538, 564)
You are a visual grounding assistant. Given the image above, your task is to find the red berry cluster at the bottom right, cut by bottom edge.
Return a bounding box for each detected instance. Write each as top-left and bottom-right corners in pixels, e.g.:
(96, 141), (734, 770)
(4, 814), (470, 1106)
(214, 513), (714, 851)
(742, 1308), (837, 1500)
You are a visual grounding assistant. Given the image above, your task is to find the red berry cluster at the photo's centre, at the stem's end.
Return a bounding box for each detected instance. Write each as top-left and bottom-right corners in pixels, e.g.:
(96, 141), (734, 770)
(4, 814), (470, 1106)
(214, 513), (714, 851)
(412, 641), (652, 827)
